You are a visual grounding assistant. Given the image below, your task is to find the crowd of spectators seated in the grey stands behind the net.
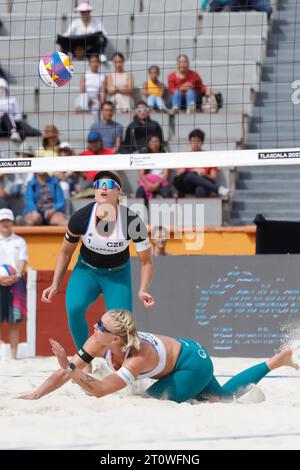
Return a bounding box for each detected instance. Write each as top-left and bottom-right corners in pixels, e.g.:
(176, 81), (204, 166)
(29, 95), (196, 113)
(0, 0), (272, 225)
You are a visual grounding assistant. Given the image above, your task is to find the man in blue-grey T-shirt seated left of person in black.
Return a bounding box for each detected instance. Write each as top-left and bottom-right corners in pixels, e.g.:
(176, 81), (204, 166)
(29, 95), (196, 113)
(90, 101), (124, 153)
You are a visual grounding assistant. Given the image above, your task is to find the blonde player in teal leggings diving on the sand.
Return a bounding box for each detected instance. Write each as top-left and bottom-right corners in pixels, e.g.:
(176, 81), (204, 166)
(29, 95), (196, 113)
(19, 310), (299, 403)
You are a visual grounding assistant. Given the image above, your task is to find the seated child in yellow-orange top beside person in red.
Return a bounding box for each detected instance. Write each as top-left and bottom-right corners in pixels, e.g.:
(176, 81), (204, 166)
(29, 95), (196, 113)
(142, 65), (166, 111)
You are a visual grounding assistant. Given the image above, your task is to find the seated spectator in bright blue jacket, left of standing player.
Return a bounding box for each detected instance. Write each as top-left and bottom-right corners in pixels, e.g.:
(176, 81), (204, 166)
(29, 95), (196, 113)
(23, 173), (67, 225)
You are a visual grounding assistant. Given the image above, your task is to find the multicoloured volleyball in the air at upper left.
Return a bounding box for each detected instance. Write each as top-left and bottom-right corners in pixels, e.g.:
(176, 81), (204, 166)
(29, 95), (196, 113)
(39, 51), (74, 88)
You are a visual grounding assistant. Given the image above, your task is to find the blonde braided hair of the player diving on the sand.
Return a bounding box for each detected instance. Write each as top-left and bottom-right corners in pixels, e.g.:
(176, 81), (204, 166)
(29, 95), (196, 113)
(107, 309), (141, 352)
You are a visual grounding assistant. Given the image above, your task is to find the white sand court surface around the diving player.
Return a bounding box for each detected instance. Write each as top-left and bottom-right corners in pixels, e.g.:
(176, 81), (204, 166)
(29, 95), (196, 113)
(0, 358), (300, 449)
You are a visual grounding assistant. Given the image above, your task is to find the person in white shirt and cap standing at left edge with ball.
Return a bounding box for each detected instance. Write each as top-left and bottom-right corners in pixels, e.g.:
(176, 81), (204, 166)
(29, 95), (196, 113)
(0, 209), (28, 359)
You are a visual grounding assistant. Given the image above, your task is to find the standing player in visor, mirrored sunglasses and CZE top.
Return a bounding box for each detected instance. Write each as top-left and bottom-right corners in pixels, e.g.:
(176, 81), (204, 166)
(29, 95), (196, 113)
(42, 171), (155, 349)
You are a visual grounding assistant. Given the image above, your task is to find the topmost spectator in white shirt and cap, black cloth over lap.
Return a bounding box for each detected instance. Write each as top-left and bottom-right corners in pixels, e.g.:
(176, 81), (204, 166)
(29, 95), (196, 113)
(57, 3), (107, 62)
